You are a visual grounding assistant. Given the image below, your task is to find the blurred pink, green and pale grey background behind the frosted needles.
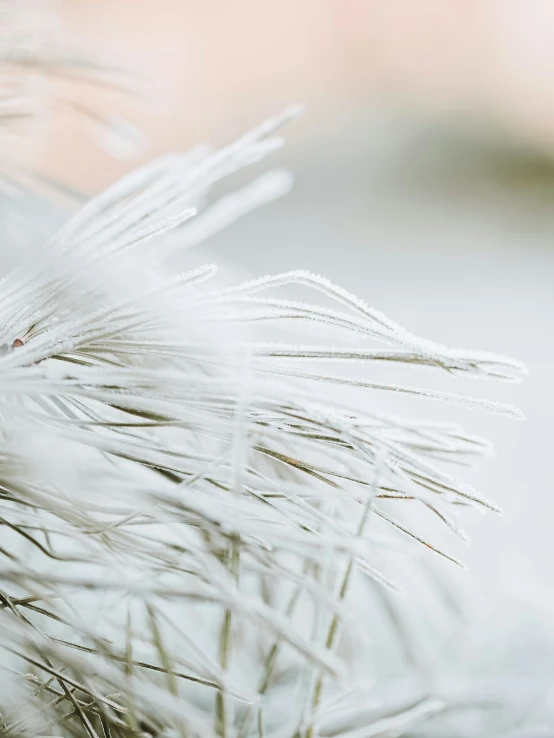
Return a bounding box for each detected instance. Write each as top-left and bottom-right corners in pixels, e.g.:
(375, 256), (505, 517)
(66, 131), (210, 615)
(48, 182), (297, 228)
(3, 0), (554, 724)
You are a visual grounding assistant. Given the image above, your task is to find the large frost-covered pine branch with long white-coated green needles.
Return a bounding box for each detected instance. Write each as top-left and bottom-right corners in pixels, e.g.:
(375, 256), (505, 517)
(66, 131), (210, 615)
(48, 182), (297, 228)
(0, 105), (524, 738)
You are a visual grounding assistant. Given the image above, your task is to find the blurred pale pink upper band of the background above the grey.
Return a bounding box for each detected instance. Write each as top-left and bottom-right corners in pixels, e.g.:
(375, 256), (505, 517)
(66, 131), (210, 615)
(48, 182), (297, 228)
(37, 0), (554, 189)
